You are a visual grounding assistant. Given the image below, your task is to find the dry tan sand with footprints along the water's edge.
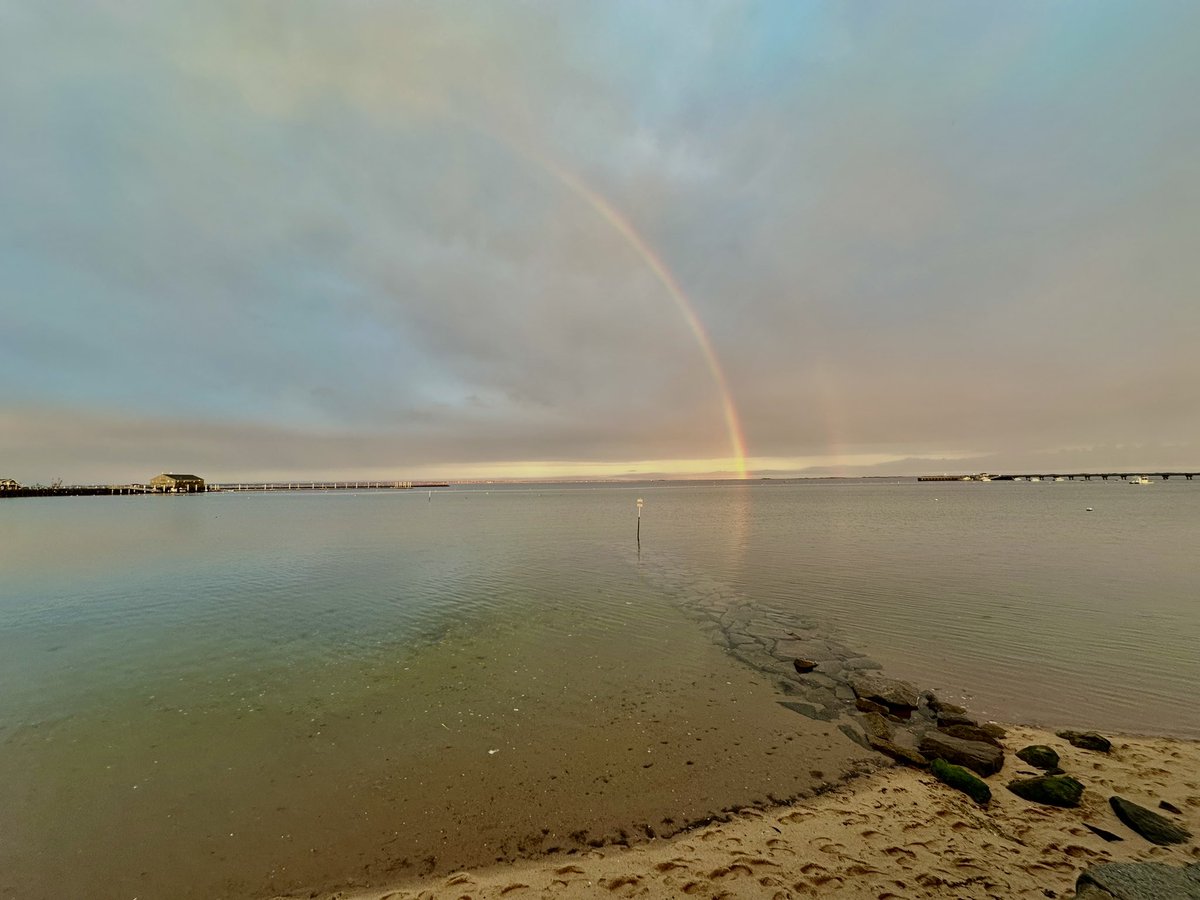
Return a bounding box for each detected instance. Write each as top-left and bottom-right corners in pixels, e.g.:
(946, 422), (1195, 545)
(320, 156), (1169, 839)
(336, 726), (1200, 900)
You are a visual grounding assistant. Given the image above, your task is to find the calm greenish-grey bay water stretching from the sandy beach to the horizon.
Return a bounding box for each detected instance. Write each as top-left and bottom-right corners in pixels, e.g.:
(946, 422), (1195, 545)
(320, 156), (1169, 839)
(0, 481), (1200, 898)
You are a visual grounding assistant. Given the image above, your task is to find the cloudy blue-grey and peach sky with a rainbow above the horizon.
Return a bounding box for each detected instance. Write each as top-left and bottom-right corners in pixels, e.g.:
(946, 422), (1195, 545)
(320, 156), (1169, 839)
(0, 0), (1200, 484)
